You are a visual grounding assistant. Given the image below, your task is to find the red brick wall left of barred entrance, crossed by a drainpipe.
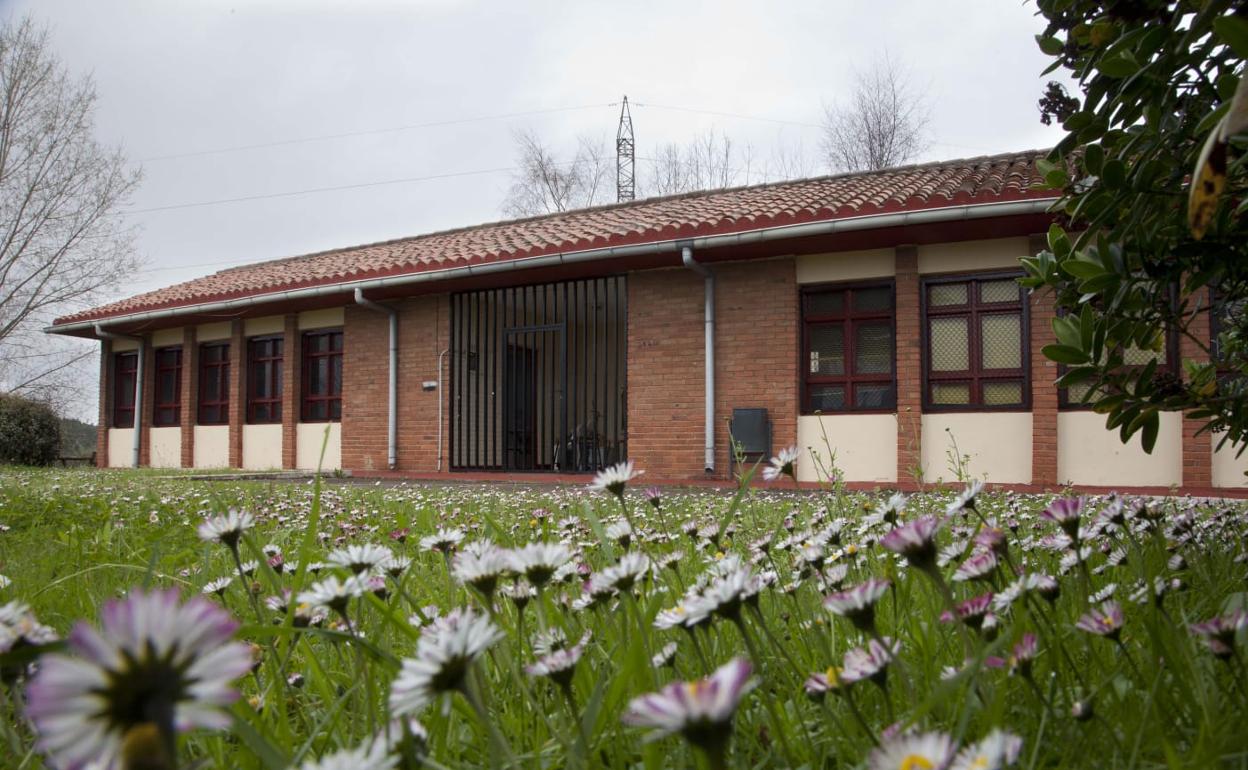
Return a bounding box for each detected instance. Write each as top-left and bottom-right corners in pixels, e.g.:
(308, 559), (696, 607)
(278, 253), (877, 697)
(342, 295), (451, 472)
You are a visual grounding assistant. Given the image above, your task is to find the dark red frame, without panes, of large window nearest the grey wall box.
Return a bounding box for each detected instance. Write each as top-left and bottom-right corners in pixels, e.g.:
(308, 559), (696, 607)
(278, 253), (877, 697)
(799, 281), (897, 414)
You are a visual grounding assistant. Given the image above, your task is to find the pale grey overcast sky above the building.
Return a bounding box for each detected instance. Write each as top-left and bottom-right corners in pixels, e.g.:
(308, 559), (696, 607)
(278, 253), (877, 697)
(7, 0), (1058, 419)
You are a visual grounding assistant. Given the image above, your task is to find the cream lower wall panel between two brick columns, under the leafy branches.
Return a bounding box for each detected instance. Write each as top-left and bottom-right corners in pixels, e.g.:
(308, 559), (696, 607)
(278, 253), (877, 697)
(1057, 411), (1183, 487)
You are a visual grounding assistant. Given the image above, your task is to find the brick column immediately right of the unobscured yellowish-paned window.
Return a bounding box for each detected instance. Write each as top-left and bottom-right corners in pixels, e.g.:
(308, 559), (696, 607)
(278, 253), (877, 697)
(1027, 235), (1058, 487)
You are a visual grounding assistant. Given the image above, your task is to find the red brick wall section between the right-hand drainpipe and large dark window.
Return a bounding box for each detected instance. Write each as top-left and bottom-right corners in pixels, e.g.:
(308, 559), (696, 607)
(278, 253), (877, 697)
(718, 258), (800, 478)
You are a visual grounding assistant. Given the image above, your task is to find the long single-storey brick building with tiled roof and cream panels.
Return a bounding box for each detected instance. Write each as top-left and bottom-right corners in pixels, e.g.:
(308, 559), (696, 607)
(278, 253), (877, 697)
(43, 152), (1244, 493)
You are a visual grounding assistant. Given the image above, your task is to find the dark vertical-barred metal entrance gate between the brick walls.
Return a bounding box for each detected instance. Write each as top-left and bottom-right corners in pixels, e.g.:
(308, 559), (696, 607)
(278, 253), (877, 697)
(451, 276), (628, 473)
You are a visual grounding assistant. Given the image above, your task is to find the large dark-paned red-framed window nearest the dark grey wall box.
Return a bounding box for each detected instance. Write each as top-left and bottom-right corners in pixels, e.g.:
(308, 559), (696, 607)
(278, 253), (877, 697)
(801, 281), (897, 414)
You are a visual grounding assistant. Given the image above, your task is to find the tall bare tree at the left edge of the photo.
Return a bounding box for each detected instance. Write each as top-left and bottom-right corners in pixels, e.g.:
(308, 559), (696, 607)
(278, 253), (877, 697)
(0, 19), (139, 409)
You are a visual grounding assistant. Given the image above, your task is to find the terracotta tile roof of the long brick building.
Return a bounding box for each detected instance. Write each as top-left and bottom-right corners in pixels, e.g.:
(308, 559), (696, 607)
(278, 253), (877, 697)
(55, 151), (1052, 324)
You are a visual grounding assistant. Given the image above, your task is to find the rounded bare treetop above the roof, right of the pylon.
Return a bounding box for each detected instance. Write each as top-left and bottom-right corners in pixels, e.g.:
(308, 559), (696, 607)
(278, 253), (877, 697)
(822, 56), (930, 171)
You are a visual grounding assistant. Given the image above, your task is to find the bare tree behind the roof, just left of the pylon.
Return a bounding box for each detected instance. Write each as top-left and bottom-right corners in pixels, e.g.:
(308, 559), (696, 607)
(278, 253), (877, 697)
(503, 131), (615, 217)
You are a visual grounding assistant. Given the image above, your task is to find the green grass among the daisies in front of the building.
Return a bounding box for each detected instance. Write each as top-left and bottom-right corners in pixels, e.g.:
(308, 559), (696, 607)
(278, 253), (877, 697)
(0, 469), (1248, 769)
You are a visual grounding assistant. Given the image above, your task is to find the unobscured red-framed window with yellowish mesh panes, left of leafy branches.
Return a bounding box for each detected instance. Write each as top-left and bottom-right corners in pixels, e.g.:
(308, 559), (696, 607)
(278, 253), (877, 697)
(922, 272), (1031, 412)
